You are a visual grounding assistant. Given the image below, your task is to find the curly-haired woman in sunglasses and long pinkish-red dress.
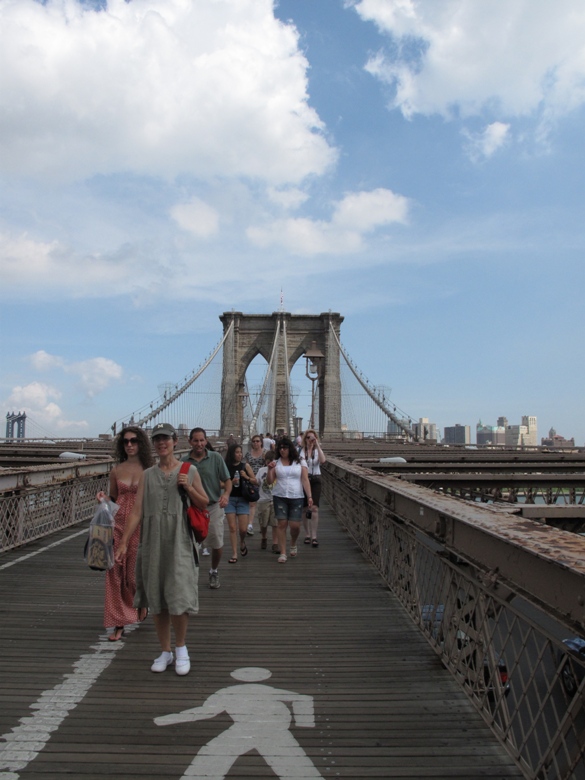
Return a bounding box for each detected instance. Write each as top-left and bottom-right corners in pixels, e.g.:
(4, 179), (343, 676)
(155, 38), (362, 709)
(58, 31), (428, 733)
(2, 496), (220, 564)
(97, 426), (154, 642)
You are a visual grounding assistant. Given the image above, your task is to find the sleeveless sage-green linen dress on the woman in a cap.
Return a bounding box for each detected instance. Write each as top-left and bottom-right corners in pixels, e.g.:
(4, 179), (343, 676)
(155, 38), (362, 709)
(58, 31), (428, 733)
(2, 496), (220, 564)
(134, 465), (199, 615)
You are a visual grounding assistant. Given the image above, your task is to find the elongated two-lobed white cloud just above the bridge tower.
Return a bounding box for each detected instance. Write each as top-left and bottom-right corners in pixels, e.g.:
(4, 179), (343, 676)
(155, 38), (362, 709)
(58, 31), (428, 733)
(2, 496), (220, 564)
(246, 188), (409, 255)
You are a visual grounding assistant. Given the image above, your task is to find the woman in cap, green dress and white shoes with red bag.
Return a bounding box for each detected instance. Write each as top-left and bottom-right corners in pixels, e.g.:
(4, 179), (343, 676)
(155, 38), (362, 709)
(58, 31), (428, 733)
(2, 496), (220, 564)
(116, 423), (209, 675)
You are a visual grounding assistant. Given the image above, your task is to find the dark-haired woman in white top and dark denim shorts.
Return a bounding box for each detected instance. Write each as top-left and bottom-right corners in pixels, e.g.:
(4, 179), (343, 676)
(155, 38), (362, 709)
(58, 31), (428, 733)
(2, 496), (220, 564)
(267, 436), (313, 563)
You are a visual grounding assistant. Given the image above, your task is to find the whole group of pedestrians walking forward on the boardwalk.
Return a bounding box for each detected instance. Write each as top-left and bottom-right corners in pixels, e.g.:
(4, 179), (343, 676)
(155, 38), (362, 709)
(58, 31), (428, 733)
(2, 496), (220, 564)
(97, 423), (325, 675)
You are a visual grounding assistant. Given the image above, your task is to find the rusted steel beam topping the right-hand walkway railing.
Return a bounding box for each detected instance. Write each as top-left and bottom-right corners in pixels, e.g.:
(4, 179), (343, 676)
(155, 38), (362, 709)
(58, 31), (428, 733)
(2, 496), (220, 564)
(323, 457), (585, 632)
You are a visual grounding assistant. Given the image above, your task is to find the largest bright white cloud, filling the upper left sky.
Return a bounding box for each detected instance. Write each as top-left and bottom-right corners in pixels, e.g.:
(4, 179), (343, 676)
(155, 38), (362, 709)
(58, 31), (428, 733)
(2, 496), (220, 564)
(0, 0), (336, 184)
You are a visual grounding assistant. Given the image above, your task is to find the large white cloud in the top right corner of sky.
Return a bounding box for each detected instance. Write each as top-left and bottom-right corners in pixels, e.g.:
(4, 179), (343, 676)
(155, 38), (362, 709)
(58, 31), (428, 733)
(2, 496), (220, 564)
(354, 0), (585, 118)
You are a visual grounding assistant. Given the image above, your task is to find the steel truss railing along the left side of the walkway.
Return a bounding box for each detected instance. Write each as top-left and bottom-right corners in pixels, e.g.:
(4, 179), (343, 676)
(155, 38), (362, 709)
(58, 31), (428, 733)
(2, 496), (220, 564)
(0, 462), (111, 553)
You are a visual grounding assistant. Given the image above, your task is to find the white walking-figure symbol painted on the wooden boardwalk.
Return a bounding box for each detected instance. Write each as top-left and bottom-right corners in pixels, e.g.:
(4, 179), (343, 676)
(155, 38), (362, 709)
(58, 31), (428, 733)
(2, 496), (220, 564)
(154, 666), (322, 780)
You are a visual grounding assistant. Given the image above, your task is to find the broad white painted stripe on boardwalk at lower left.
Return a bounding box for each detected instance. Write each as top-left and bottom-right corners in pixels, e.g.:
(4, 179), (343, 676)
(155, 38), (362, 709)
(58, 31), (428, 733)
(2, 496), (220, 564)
(0, 632), (130, 780)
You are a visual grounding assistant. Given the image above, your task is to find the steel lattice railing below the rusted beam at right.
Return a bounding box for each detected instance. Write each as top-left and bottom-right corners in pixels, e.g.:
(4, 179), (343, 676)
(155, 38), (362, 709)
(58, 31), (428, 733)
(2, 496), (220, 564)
(322, 459), (585, 780)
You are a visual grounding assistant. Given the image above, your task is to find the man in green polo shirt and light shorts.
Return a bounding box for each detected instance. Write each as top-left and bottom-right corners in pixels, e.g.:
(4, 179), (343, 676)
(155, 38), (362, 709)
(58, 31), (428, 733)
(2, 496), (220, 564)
(183, 428), (232, 589)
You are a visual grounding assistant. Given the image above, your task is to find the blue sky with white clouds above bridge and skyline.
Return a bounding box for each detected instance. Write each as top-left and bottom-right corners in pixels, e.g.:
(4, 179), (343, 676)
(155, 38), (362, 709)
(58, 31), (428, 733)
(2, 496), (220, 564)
(0, 0), (585, 445)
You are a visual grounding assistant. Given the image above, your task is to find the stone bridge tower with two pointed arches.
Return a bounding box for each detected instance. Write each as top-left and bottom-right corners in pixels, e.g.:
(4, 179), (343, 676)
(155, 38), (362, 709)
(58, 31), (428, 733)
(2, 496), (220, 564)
(220, 311), (343, 438)
